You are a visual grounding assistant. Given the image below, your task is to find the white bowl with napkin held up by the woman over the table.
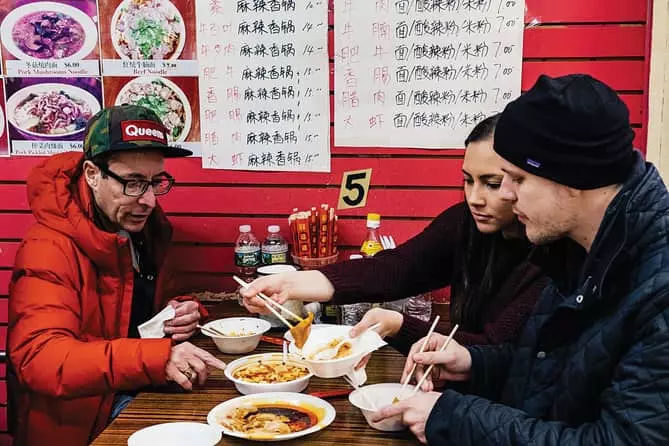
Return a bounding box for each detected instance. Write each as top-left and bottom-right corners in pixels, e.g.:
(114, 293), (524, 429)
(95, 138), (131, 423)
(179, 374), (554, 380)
(286, 325), (386, 378)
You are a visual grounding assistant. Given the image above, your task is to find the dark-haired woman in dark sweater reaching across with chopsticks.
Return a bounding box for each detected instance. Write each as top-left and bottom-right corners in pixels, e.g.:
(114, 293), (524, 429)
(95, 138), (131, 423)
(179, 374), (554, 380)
(240, 115), (547, 353)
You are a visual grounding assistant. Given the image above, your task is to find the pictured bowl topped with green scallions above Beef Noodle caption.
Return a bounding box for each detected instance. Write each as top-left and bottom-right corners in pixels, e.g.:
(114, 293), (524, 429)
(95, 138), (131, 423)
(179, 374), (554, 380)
(111, 0), (186, 60)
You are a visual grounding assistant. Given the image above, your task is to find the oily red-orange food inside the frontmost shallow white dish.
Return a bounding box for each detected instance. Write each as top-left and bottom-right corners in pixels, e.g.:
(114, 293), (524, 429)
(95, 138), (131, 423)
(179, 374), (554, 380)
(219, 403), (318, 435)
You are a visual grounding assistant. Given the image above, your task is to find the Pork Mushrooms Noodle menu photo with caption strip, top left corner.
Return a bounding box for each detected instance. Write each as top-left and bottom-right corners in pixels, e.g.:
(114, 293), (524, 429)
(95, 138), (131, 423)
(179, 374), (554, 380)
(0, 0), (100, 77)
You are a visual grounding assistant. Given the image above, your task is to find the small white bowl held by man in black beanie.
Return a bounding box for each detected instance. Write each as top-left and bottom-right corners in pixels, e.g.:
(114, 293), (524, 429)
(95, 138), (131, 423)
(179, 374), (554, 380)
(348, 383), (422, 432)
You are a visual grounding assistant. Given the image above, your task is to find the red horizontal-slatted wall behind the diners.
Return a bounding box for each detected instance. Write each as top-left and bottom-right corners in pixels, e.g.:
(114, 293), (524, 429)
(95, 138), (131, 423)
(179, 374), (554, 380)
(0, 0), (650, 440)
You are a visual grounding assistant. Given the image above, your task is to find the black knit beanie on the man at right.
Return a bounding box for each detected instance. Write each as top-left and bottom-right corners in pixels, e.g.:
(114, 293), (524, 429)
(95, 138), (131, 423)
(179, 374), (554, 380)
(494, 74), (635, 190)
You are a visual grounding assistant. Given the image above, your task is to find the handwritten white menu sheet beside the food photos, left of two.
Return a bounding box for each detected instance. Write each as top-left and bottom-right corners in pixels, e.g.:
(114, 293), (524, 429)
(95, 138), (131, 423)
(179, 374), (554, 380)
(196, 0), (330, 172)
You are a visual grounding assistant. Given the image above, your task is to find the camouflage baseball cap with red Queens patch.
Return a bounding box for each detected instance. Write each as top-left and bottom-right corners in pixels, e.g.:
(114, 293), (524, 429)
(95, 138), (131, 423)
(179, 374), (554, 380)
(84, 104), (193, 159)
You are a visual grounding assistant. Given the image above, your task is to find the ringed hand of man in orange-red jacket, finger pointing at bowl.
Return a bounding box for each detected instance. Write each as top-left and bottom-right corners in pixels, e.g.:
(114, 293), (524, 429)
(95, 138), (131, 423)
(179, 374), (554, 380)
(165, 342), (225, 390)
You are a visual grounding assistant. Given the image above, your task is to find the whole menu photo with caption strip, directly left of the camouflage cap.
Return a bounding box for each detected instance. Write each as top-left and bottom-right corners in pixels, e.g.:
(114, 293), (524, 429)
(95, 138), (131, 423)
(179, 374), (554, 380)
(5, 77), (102, 155)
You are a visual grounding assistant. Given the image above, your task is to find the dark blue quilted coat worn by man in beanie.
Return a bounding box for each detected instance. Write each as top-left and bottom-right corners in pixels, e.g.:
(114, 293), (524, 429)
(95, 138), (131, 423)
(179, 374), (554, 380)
(426, 155), (669, 446)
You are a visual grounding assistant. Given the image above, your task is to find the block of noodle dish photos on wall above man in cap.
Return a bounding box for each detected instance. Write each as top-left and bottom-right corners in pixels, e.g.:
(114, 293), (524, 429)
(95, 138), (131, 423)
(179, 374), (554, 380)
(0, 0), (201, 156)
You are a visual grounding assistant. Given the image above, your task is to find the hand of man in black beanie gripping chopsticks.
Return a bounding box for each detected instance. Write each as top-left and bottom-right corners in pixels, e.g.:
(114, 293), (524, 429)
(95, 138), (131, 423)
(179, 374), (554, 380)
(402, 333), (472, 392)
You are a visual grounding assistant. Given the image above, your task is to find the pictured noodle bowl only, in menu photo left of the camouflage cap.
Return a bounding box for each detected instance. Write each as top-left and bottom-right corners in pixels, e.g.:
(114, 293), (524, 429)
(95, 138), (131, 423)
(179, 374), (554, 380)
(6, 83), (100, 139)
